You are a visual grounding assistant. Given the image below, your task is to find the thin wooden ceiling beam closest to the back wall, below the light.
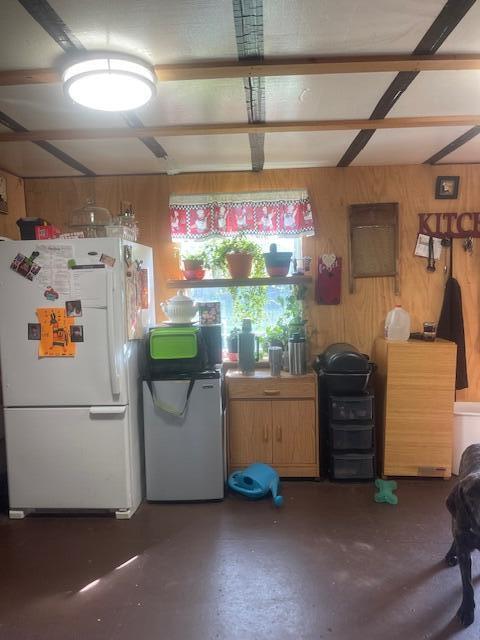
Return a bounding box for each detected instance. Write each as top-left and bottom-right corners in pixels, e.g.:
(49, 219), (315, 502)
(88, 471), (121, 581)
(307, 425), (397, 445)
(0, 115), (480, 142)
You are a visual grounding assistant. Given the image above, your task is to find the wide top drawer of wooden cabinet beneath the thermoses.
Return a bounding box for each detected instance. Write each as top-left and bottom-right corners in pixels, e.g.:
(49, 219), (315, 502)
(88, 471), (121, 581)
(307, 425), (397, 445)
(228, 376), (315, 398)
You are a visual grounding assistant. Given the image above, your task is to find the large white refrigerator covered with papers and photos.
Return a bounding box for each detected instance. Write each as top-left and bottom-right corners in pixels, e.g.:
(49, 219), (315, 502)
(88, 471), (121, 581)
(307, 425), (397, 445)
(0, 238), (155, 518)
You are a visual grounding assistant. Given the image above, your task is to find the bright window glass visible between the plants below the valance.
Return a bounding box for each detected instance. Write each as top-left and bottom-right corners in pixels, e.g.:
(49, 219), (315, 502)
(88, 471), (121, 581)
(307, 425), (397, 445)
(176, 236), (302, 339)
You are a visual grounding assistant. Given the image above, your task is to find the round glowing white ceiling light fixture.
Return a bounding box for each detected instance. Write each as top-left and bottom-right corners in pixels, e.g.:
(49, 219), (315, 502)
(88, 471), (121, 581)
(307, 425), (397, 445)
(62, 53), (156, 111)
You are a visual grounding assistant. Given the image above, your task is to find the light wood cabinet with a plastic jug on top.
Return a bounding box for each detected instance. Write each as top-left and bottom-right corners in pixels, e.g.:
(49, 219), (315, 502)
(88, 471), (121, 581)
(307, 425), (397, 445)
(374, 338), (456, 478)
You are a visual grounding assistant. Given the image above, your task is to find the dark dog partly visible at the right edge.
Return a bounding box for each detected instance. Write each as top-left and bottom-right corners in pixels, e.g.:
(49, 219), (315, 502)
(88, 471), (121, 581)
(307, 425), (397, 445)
(445, 444), (480, 627)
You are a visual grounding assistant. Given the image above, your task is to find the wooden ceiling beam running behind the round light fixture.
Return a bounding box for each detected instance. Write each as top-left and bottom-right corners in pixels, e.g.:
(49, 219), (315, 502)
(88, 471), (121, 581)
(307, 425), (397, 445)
(4, 54), (480, 86)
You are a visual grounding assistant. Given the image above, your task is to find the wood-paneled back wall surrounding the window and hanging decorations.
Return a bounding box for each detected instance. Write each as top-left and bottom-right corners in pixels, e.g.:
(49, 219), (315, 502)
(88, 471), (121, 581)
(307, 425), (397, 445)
(25, 165), (480, 400)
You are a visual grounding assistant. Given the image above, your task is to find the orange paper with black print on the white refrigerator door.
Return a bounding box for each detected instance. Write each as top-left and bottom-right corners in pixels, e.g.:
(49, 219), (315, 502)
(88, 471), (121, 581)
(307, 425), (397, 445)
(37, 307), (76, 358)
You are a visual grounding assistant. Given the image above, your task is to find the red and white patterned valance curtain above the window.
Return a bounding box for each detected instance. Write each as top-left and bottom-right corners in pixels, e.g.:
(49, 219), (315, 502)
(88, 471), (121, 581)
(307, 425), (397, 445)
(169, 191), (315, 240)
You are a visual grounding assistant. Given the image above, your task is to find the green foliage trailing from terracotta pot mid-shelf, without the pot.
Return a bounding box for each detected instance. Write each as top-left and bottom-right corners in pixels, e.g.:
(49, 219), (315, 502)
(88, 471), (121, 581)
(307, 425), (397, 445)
(205, 235), (267, 322)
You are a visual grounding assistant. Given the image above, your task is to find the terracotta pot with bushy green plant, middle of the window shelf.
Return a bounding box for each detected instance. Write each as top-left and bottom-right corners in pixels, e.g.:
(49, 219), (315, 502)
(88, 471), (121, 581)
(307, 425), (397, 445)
(209, 235), (265, 278)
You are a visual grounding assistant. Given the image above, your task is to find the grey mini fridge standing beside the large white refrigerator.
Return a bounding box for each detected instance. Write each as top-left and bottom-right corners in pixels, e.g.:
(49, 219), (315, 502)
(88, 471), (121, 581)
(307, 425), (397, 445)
(143, 371), (225, 501)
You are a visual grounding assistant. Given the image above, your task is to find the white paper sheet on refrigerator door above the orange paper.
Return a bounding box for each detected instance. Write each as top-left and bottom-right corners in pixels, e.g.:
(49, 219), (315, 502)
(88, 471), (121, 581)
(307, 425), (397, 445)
(35, 243), (79, 298)
